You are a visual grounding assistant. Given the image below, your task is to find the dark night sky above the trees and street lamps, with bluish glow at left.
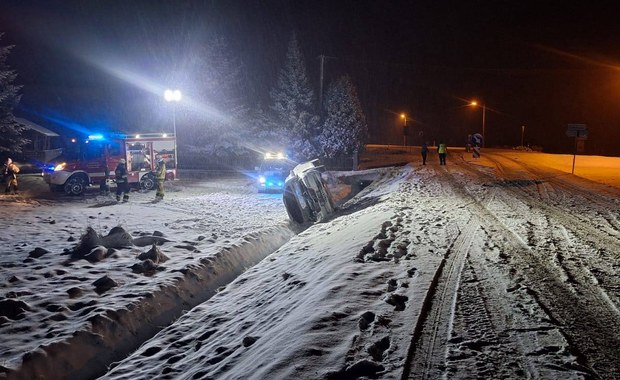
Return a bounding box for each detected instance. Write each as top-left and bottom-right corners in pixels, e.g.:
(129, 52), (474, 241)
(0, 0), (620, 155)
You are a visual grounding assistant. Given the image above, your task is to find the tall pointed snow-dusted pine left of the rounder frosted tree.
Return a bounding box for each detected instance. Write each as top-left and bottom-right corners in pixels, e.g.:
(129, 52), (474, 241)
(271, 35), (319, 160)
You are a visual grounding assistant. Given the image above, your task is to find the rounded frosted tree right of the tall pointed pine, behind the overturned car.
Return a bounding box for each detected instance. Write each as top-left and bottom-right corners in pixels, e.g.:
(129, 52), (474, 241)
(318, 76), (368, 158)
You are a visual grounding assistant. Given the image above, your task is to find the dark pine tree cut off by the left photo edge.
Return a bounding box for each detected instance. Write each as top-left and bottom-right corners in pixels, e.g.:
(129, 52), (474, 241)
(0, 34), (28, 152)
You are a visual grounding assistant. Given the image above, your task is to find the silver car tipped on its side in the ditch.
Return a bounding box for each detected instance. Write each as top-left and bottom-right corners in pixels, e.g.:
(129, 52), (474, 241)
(282, 160), (335, 224)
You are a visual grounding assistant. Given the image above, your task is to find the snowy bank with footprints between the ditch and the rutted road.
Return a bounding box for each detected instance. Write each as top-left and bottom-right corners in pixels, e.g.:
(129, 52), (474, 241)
(106, 168), (455, 379)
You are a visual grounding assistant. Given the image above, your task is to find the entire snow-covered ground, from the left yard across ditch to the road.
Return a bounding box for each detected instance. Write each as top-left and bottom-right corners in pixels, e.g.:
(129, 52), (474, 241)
(0, 147), (620, 379)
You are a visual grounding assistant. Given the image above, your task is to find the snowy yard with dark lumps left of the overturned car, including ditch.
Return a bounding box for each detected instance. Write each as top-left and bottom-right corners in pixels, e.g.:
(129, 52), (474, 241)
(0, 176), (294, 379)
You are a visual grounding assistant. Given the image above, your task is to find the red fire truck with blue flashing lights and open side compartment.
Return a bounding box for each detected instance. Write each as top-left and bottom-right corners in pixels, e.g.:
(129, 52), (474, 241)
(43, 133), (177, 195)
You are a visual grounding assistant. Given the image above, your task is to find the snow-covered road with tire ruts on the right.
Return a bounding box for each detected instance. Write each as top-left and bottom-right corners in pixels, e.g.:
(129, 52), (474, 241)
(407, 152), (620, 379)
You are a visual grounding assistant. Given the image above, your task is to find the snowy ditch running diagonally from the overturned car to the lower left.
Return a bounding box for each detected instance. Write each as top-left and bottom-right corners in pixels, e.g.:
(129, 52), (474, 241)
(0, 226), (294, 379)
